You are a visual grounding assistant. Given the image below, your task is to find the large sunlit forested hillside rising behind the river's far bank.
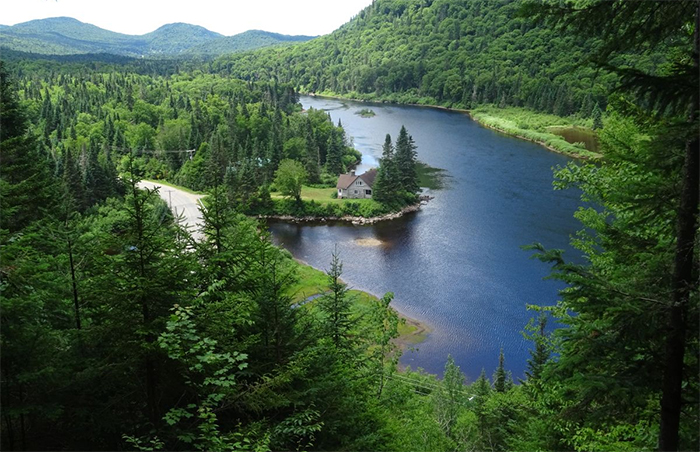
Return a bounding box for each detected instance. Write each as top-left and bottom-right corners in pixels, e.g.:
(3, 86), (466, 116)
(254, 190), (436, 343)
(217, 0), (615, 117)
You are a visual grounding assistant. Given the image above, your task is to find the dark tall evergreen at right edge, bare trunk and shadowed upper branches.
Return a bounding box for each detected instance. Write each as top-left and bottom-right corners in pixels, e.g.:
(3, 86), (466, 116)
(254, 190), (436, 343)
(525, 0), (700, 450)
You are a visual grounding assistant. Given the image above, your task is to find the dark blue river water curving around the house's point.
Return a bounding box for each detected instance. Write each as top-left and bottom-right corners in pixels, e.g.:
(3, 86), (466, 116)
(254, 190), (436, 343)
(270, 97), (580, 381)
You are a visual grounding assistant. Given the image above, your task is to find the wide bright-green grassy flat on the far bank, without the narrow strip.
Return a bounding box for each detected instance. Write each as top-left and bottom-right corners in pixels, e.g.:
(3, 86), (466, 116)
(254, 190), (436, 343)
(471, 106), (602, 159)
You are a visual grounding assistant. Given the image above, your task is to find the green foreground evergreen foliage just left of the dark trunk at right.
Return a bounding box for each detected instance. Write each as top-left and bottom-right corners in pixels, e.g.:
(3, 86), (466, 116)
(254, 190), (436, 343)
(524, 107), (698, 449)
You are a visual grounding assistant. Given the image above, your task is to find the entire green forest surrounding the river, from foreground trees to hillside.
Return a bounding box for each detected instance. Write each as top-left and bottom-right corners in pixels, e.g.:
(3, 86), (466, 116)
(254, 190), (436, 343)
(0, 0), (700, 452)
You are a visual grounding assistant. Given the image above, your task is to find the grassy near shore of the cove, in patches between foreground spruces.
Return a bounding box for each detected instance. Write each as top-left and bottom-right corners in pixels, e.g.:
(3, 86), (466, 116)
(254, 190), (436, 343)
(288, 259), (431, 351)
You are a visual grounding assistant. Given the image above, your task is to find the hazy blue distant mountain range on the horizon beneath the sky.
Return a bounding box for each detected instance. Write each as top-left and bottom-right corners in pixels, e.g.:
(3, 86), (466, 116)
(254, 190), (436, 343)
(0, 17), (312, 57)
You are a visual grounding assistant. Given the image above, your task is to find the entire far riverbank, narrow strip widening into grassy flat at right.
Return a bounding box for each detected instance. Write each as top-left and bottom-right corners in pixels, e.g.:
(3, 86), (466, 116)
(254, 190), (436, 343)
(307, 93), (602, 160)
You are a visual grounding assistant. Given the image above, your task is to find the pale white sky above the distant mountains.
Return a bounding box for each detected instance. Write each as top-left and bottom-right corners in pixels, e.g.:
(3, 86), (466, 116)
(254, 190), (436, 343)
(0, 0), (372, 36)
